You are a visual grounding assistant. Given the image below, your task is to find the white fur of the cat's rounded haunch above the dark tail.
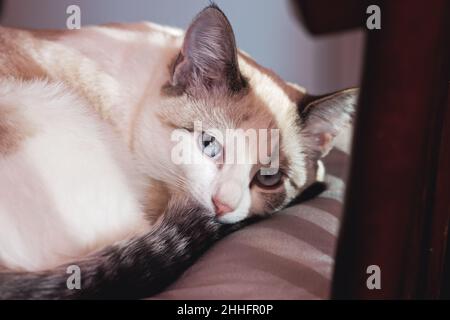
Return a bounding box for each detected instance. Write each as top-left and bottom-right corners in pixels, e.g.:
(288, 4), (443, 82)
(0, 80), (147, 270)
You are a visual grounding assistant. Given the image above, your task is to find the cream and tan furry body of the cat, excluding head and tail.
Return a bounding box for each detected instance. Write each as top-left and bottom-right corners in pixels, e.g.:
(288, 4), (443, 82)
(0, 24), (181, 270)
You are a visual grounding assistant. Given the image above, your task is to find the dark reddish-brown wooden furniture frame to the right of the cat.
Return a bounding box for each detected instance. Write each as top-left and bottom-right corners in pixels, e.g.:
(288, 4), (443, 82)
(292, 0), (450, 299)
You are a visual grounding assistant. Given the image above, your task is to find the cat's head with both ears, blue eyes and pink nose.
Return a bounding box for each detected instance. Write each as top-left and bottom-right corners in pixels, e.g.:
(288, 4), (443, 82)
(156, 6), (357, 223)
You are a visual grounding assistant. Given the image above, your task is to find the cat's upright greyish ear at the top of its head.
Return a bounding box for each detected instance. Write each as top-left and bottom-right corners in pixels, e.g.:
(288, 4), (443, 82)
(171, 5), (245, 94)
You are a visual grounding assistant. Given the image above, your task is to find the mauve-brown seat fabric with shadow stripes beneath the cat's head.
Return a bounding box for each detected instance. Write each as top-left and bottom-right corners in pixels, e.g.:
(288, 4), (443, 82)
(154, 149), (348, 299)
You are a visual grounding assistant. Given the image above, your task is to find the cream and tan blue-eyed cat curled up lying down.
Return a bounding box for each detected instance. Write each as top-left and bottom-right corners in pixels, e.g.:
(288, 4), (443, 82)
(0, 4), (358, 298)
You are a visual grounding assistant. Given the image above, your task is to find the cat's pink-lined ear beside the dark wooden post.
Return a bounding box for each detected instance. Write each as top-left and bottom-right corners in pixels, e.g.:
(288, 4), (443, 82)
(299, 88), (359, 158)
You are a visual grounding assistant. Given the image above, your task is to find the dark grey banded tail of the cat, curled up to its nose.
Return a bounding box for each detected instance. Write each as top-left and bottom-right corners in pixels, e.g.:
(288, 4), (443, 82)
(0, 201), (248, 299)
